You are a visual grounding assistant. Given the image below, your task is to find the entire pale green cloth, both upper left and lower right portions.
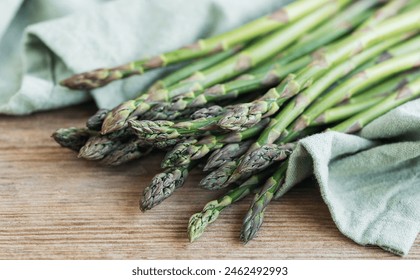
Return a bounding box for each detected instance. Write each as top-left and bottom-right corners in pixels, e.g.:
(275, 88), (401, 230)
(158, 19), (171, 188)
(0, 0), (420, 255)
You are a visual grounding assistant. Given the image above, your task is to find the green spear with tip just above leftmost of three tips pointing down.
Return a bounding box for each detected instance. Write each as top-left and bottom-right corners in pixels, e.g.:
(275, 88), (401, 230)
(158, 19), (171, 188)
(162, 119), (269, 168)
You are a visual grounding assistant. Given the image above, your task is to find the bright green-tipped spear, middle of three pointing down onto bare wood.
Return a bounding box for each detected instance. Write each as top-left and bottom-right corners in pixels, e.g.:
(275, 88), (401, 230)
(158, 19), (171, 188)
(188, 166), (274, 242)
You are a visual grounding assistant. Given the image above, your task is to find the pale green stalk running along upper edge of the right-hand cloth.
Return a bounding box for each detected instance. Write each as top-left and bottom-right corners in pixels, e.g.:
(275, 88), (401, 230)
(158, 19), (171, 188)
(331, 78), (420, 133)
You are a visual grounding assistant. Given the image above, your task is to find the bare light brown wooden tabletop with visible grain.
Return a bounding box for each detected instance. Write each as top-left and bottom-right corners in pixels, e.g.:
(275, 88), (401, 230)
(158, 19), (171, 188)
(0, 104), (420, 259)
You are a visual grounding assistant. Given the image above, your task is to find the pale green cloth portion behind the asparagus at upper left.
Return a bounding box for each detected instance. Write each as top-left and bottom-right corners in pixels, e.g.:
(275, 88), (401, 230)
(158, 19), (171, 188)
(0, 0), (287, 114)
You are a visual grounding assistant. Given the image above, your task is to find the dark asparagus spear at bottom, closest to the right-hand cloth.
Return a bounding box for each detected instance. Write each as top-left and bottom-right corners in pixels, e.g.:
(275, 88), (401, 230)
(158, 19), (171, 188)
(240, 160), (288, 243)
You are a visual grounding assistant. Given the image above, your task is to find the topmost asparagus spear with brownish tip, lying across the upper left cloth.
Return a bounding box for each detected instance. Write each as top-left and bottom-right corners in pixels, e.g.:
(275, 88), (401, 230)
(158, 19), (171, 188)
(61, 0), (329, 90)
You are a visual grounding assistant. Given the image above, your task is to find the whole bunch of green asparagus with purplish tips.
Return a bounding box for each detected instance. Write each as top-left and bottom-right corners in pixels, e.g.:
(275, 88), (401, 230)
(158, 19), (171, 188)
(53, 0), (420, 243)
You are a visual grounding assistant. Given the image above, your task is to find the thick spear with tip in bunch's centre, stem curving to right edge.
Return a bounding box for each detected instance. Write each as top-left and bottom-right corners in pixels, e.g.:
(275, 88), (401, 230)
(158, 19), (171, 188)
(218, 10), (420, 133)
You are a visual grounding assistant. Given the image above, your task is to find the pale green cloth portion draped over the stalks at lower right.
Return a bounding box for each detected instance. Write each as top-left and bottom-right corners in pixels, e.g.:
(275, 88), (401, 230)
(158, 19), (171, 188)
(286, 100), (420, 255)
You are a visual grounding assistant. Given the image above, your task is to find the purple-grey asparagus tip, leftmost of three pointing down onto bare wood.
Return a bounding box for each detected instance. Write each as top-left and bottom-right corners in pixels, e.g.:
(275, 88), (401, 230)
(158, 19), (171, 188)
(140, 162), (197, 211)
